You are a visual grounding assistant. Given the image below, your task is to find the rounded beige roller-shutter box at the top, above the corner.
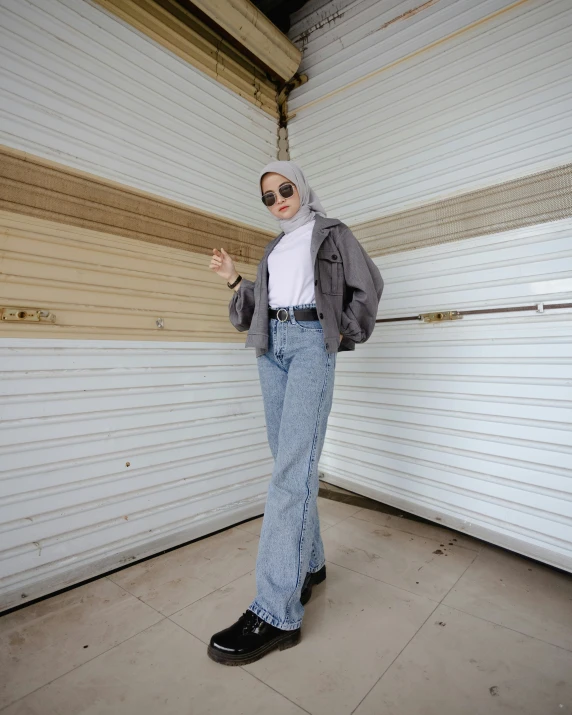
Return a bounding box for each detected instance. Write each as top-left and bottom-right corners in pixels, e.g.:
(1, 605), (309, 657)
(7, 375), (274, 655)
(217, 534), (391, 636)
(193, 0), (302, 80)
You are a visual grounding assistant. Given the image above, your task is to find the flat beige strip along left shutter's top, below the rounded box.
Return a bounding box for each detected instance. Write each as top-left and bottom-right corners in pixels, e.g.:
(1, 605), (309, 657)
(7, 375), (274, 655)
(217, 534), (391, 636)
(95, 0), (277, 116)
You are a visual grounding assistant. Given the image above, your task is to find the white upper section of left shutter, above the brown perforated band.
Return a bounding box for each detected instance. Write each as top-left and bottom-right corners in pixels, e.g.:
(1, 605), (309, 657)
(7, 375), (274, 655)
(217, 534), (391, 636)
(0, 0), (276, 229)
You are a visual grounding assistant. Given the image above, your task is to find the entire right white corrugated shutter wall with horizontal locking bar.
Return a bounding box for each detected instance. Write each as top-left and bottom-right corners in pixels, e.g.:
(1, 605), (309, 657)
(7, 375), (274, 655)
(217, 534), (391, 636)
(289, 0), (572, 570)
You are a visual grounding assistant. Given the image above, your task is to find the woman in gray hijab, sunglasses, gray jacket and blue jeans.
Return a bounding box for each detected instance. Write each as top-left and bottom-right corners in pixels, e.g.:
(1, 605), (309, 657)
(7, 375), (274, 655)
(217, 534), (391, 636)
(208, 161), (383, 665)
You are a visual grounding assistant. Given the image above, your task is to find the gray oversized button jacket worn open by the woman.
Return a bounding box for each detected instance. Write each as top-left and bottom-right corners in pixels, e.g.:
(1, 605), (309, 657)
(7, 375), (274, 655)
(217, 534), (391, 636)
(229, 216), (383, 357)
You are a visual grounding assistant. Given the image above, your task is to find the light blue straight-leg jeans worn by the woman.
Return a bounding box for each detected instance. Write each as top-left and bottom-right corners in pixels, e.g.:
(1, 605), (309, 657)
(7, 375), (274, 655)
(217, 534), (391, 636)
(250, 305), (336, 630)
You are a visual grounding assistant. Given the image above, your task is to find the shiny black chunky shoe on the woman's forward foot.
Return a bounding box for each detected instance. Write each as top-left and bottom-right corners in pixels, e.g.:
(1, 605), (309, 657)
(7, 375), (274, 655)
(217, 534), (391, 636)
(207, 611), (300, 665)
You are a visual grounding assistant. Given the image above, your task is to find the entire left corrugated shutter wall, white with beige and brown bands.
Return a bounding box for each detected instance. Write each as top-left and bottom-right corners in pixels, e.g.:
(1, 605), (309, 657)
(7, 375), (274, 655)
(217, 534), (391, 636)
(0, 0), (276, 609)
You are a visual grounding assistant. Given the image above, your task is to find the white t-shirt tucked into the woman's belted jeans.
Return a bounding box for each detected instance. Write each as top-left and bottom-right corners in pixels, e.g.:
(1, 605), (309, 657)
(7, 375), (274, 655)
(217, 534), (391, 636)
(268, 221), (315, 308)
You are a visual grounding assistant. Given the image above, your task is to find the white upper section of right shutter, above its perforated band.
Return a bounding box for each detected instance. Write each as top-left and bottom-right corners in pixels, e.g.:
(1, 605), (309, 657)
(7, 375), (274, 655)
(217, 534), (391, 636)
(289, 0), (572, 224)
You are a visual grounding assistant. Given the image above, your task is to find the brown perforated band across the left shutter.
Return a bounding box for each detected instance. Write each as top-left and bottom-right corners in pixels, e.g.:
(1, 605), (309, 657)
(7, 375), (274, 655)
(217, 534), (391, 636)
(0, 146), (274, 264)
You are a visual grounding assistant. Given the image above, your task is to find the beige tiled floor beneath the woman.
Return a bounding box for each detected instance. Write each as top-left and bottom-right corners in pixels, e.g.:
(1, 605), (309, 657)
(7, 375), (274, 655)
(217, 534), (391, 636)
(0, 499), (572, 715)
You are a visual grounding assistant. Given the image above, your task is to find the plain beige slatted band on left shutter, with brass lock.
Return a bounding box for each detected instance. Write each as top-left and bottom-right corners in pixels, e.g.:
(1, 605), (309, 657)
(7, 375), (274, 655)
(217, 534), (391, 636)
(0, 212), (254, 342)
